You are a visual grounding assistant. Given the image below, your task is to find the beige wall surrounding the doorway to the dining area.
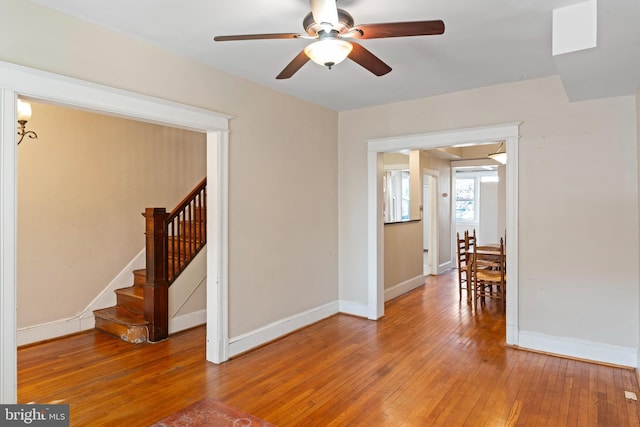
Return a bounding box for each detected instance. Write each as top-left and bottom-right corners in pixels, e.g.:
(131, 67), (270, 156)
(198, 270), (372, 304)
(339, 77), (639, 348)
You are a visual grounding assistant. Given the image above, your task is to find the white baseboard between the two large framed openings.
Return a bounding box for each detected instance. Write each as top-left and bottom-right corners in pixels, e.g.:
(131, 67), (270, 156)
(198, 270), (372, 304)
(229, 301), (339, 357)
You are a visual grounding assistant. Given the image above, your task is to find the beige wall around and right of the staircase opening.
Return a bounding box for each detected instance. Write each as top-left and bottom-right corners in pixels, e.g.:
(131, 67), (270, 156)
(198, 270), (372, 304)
(0, 0), (338, 337)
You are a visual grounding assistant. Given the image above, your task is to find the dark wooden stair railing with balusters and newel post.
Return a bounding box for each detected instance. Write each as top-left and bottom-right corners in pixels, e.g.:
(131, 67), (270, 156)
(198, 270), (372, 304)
(143, 178), (207, 342)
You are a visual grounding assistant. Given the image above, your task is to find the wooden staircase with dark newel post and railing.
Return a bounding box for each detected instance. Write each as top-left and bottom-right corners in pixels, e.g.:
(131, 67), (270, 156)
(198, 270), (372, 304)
(93, 178), (207, 344)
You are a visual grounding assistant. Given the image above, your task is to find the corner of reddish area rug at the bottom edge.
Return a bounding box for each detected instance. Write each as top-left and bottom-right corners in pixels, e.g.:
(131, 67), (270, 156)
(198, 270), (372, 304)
(151, 397), (275, 427)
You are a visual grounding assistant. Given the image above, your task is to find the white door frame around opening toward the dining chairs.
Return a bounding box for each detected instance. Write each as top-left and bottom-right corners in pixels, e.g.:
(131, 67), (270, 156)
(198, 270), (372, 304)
(367, 122), (522, 345)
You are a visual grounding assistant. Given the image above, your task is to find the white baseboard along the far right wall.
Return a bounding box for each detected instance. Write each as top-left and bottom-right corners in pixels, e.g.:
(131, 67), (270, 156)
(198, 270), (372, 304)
(518, 331), (638, 368)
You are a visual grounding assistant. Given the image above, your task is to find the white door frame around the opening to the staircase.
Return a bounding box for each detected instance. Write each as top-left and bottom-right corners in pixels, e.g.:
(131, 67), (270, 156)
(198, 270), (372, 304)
(0, 61), (231, 403)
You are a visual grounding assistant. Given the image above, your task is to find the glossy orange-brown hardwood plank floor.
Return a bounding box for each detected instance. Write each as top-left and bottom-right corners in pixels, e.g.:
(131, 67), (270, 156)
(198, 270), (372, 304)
(18, 271), (640, 426)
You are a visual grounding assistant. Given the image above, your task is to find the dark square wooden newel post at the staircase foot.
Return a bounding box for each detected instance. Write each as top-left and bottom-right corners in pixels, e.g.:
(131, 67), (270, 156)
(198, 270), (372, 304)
(144, 208), (169, 342)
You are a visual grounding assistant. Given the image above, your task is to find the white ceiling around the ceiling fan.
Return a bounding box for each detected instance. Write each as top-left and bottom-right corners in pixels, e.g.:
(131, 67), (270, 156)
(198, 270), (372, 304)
(34, 0), (640, 111)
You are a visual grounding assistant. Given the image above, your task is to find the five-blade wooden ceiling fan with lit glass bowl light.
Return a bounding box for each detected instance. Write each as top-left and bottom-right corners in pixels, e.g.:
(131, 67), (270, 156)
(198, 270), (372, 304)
(213, 0), (444, 79)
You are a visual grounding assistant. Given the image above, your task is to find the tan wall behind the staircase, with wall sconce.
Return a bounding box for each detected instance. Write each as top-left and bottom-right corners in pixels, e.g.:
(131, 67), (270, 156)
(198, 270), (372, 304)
(18, 102), (206, 327)
